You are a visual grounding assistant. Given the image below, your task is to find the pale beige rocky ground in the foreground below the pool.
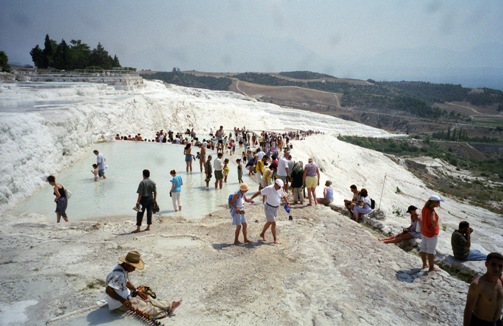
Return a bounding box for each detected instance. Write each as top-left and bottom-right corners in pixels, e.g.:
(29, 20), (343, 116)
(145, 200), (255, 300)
(0, 205), (468, 325)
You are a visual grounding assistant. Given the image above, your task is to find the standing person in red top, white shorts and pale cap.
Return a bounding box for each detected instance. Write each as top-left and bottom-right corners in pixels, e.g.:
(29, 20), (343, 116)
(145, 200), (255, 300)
(420, 195), (443, 272)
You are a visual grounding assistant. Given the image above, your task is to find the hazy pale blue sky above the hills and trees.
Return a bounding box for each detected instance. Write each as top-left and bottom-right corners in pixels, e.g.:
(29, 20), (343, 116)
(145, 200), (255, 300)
(0, 0), (503, 89)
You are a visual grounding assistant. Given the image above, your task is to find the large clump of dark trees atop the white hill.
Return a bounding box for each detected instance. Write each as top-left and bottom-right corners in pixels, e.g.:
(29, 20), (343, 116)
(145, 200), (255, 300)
(30, 35), (121, 70)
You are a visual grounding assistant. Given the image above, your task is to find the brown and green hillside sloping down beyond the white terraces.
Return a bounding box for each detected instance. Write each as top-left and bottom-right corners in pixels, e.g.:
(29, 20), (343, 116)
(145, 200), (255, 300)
(140, 70), (503, 213)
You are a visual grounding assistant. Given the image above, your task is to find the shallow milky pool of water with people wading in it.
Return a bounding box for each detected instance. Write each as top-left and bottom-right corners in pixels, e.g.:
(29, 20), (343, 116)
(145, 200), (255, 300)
(11, 141), (256, 220)
